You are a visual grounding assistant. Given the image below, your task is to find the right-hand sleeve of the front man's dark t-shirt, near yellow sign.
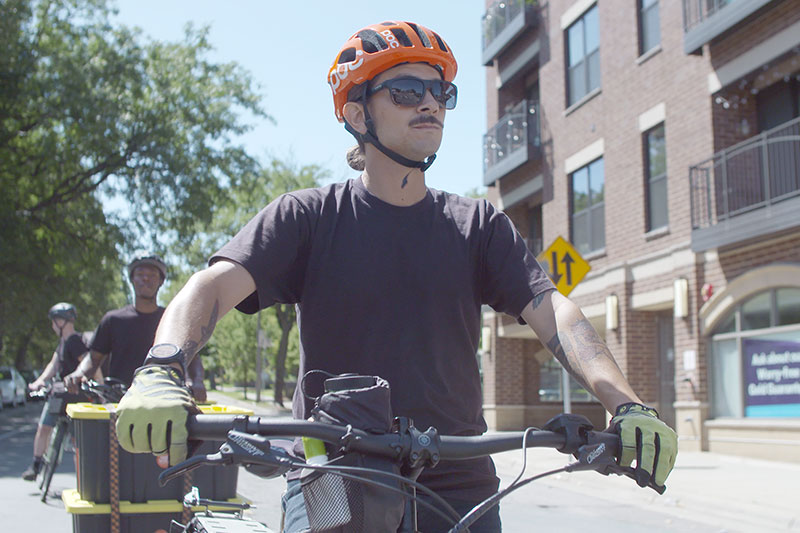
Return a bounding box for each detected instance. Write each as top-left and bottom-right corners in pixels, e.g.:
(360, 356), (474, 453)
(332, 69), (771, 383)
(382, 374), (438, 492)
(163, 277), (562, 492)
(481, 202), (555, 319)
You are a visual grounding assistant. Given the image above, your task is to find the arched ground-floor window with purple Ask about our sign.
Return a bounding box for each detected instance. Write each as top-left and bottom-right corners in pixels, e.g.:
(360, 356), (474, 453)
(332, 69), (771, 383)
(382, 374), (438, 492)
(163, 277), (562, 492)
(709, 288), (800, 418)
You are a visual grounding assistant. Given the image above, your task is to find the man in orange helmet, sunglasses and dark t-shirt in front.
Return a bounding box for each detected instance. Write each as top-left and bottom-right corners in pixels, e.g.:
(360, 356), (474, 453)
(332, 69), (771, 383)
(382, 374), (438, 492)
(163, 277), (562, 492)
(112, 21), (677, 533)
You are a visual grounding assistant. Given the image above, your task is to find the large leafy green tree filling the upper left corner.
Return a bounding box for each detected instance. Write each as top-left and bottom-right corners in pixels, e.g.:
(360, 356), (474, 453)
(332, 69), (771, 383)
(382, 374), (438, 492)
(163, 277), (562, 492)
(0, 0), (266, 363)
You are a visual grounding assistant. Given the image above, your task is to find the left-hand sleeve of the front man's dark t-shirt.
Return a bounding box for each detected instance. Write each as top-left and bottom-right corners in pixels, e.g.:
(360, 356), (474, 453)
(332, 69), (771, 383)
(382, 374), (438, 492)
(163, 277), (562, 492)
(209, 194), (311, 314)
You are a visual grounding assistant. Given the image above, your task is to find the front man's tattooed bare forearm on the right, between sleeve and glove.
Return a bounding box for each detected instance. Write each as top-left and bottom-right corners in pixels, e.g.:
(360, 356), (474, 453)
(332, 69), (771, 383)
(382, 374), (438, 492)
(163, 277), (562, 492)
(522, 291), (641, 413)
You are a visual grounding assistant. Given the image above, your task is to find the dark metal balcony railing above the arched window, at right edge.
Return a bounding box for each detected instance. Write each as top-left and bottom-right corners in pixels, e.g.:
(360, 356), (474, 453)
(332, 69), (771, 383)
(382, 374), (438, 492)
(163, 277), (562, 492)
(689, 118), (800, 229)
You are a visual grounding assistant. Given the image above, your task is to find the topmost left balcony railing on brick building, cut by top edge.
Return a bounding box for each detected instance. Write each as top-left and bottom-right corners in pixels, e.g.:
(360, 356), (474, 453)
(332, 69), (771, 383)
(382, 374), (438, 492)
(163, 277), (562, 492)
(481, 0), (538, 65)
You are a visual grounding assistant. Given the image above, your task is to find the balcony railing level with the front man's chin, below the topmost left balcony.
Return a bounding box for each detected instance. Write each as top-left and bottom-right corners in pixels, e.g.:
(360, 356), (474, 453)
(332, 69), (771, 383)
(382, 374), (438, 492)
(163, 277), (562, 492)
(483, 100), (540, 183)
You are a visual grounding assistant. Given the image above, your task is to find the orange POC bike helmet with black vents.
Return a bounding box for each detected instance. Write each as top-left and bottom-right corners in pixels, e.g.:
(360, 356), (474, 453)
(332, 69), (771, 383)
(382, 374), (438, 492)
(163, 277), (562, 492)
(328, 21), (458, 122)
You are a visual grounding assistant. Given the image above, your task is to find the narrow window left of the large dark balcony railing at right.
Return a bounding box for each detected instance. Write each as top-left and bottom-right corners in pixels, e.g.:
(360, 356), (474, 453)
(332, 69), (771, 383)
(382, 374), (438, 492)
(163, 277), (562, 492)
(644, 124), (669, 231)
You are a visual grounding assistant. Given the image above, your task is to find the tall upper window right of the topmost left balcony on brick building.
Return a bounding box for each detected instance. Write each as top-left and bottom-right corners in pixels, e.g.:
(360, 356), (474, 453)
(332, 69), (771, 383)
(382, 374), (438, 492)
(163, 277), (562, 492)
(566, 5), (600, 106)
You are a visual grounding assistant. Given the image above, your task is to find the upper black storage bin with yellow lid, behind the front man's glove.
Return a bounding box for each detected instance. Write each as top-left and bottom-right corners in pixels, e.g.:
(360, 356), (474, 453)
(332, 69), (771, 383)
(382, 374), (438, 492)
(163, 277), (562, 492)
(67, 403), (253, 504)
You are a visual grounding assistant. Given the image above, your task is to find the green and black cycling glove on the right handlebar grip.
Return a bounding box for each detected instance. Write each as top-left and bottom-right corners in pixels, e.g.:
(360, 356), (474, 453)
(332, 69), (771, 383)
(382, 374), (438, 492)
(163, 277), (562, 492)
(611, 402), (678, 487)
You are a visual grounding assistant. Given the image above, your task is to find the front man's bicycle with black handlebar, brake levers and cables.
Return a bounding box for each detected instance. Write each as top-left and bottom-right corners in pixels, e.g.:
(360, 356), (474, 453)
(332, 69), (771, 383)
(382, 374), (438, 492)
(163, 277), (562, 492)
(159, 414), (664, 533)
